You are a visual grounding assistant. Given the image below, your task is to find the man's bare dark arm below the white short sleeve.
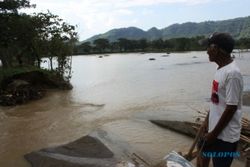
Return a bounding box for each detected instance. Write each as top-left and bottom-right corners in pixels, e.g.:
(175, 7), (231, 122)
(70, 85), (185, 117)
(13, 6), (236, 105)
(205, 105), (237, 142)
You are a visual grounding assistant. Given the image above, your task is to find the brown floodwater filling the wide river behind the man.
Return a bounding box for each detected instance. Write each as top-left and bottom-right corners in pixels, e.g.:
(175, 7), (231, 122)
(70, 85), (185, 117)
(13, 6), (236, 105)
(0, 52), (250, 167)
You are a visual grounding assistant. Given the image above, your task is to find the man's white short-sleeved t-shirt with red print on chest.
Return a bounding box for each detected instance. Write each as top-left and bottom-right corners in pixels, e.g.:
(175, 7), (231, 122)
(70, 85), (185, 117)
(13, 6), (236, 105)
(208, 61), (243, 143)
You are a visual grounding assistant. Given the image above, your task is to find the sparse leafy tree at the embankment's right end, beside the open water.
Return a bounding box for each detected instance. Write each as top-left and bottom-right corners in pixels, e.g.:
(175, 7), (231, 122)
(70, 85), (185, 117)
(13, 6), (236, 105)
(34, 11), (77, 79)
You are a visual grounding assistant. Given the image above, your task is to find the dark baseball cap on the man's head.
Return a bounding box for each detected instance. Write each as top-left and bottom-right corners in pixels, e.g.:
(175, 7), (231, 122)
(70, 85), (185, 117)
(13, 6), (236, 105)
(199, 32), (235, 53)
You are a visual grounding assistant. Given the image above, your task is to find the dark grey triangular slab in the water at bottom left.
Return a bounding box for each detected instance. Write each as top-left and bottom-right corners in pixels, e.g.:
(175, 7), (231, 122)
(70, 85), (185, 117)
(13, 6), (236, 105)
(24, 136), (118, 167)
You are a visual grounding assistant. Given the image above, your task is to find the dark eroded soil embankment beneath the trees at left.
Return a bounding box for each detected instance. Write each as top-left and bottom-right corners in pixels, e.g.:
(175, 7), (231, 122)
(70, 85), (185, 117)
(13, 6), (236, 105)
(0, 70), (73, 106)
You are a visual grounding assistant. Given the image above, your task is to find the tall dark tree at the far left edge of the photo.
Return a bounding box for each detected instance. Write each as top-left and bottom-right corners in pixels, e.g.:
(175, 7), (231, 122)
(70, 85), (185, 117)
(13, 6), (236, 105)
(0, 0), (34, 68)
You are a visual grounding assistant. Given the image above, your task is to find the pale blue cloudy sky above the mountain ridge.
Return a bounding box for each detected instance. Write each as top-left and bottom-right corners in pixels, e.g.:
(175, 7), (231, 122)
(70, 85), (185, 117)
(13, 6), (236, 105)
(25, 0), (250, 41)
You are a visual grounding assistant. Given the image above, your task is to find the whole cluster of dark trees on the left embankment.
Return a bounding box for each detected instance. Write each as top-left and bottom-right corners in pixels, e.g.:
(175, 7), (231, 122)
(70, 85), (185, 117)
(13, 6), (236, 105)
(0, 0), (77, 81)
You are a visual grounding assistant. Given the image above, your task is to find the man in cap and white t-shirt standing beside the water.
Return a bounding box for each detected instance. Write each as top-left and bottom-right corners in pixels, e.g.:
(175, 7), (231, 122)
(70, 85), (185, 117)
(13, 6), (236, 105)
(201, 33), (243, 167)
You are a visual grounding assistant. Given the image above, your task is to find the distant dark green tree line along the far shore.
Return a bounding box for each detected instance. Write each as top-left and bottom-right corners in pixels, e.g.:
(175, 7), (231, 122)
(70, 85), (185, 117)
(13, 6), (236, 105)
(74, 36), (250, 54)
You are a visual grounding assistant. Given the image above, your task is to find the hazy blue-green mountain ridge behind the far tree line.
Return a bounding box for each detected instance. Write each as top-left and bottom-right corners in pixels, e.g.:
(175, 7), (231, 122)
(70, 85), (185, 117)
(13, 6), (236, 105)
(83, 16), (250, 42)
